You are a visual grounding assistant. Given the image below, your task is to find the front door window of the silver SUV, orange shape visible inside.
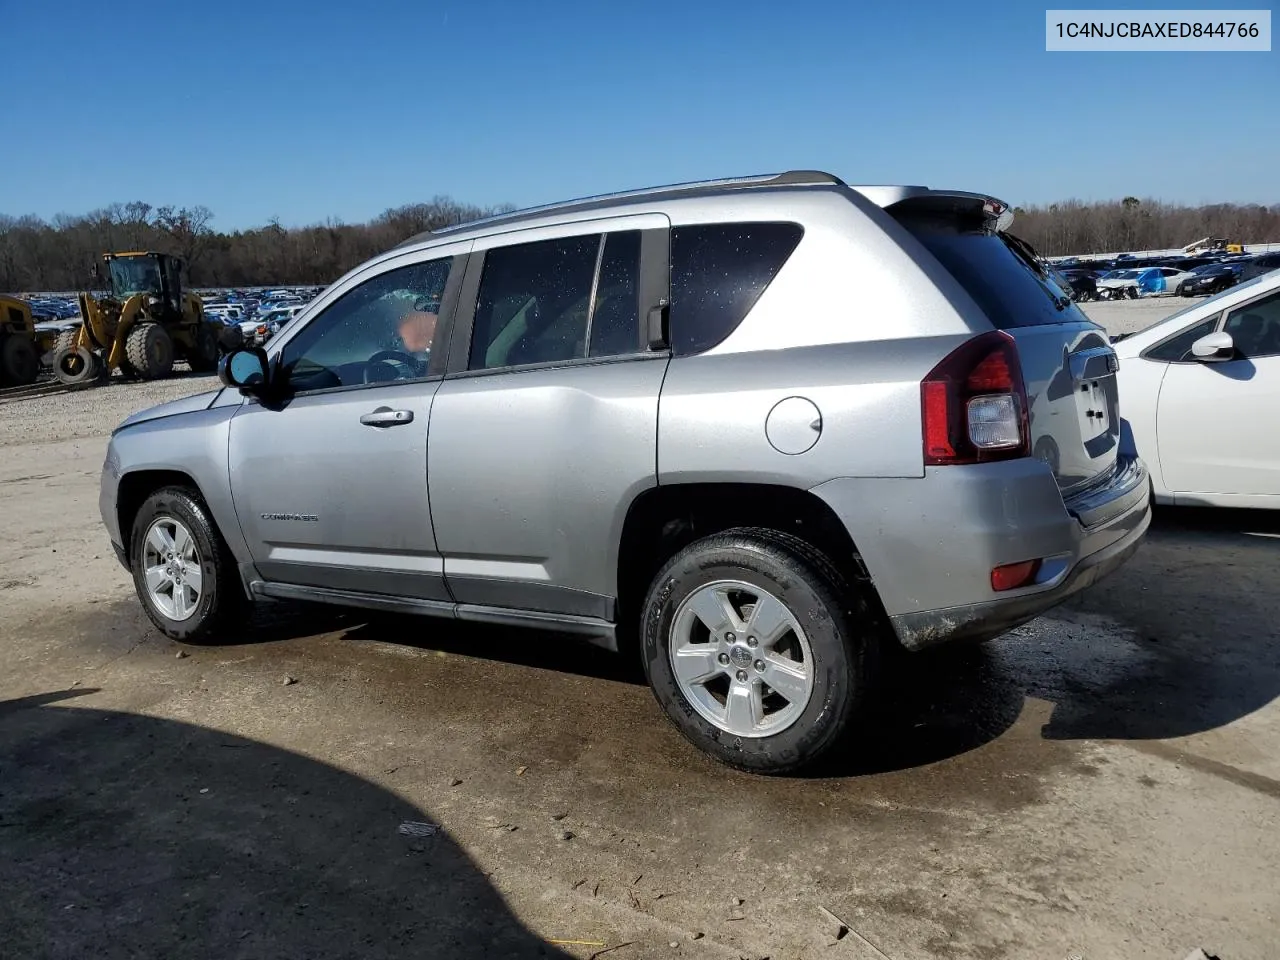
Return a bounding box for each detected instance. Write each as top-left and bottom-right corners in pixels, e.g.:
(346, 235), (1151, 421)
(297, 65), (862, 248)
(282, 259), (452, 392)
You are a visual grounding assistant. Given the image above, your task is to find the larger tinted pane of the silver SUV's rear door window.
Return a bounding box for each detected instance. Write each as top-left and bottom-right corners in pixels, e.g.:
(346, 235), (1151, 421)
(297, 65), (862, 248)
(468, 234), (600, 370)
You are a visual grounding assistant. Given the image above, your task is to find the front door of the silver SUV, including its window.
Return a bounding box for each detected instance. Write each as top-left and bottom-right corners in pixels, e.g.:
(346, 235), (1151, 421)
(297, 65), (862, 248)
(229, 248), (465, 600)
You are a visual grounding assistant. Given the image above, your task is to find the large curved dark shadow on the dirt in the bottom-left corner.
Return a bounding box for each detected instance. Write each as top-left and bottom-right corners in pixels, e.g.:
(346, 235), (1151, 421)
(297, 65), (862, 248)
(0, 690), (568, 960)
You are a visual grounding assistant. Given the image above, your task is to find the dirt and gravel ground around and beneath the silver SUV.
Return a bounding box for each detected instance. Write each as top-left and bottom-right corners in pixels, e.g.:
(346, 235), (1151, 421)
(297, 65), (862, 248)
(0, 296), (1280, 960)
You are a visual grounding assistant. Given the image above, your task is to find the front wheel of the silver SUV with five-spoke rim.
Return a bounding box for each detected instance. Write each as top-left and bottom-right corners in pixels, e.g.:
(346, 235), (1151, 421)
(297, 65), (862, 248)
(129, 486), (248, 644)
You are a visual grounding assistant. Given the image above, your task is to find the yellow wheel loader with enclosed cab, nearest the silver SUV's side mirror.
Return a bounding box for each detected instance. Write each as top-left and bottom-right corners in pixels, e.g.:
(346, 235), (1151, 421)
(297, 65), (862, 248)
(54, 252), (221, 383)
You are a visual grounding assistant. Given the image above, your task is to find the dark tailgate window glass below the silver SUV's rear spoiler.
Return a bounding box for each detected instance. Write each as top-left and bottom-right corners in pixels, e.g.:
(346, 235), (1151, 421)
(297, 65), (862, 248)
(897, 215), (1089, 330)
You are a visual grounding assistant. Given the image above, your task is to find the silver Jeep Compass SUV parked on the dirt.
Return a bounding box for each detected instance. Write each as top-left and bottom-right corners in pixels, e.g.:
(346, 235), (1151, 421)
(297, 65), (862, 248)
(94, 172), (1149, 772)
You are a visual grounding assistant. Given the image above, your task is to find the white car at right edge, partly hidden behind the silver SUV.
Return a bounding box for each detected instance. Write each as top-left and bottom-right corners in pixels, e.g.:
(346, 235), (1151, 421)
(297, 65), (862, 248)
(1112, 271), (1280, 509)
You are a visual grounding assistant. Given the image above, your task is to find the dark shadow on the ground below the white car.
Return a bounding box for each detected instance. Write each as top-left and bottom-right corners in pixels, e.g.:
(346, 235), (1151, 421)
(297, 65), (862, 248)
(1029, 507), (1280, 740)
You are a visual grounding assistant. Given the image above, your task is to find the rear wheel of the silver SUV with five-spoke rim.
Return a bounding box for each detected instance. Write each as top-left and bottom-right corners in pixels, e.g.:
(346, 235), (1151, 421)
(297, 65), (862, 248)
(640, 527), (881, 774)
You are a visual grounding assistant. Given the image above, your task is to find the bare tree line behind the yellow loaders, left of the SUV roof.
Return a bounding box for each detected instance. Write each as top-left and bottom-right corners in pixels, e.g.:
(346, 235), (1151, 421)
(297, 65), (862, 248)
(0, 197), (512, 292)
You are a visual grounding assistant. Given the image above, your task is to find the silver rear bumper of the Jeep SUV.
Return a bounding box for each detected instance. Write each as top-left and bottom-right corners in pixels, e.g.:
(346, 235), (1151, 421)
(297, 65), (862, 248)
(813, 457), (1151, 650)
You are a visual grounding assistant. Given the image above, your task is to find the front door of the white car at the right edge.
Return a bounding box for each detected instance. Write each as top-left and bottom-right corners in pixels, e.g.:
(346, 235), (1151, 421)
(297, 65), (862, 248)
(1156, 293), (1280, 506)
